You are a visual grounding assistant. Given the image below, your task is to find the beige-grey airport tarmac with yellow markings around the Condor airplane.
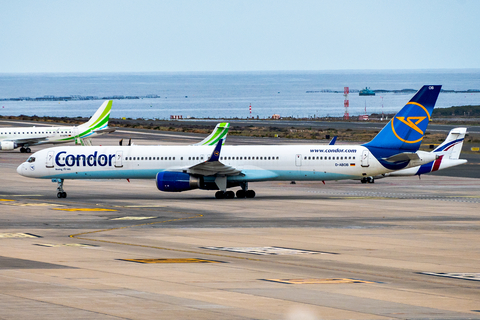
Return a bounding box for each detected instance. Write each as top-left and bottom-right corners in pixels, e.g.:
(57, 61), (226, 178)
(0, 129), (480, 320)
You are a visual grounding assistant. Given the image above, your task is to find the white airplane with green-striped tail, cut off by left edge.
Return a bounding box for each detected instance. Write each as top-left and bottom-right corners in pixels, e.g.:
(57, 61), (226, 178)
(0, 100), (115, 153)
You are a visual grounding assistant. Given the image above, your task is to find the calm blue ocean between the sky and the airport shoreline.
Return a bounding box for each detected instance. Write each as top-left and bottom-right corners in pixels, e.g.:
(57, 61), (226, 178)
(0, 69), (480, 119)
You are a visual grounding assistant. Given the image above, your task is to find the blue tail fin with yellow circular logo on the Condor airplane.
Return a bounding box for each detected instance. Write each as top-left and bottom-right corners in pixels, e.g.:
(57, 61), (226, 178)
(364, 85), (442, 152)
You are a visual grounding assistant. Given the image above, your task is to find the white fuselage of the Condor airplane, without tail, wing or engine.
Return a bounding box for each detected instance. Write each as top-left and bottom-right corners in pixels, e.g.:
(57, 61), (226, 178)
(17, 145), (391, 182)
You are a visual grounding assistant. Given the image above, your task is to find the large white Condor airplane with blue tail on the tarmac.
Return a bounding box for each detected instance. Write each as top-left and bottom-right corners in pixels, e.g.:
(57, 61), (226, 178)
(17, 85), (441, 199)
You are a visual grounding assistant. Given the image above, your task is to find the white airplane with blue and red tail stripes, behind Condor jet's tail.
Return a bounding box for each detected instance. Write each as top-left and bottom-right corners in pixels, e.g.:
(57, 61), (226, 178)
(370, 128), (468, 183)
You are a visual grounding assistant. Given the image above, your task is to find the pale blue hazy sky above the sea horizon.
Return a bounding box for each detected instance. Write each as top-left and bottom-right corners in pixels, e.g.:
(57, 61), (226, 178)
(0, 0), (480, 73)
